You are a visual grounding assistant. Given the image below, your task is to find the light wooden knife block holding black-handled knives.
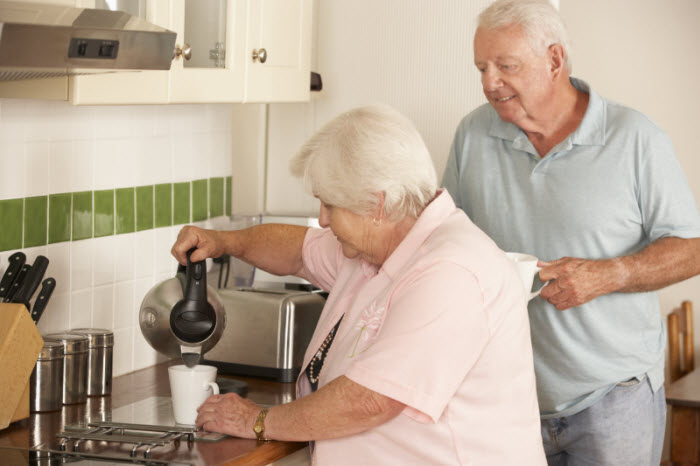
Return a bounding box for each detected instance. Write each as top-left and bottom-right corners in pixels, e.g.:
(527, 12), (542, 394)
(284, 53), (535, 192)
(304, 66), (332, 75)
(0, 303), (44, 429)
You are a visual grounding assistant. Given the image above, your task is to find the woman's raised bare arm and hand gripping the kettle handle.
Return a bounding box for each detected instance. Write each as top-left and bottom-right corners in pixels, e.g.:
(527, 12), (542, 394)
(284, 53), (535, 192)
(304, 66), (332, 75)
(172, 223), (308, 278)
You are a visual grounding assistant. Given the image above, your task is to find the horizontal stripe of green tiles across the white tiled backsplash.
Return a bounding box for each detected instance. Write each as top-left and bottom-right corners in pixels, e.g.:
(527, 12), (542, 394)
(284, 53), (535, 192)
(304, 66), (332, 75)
(0, 176), (232, 251)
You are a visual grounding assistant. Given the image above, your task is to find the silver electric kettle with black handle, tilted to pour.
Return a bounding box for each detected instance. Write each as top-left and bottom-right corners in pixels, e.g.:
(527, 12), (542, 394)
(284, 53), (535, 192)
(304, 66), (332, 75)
(139, 249), (226, 367)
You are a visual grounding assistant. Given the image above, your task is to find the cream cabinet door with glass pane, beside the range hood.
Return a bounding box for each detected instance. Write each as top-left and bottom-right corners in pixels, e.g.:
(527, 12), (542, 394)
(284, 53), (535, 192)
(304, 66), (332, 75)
(169, 0), (246, 103)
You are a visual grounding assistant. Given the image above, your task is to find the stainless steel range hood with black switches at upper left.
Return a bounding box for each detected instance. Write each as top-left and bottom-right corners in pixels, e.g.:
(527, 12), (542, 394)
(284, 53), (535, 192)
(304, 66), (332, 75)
(0, 1), (176, 81)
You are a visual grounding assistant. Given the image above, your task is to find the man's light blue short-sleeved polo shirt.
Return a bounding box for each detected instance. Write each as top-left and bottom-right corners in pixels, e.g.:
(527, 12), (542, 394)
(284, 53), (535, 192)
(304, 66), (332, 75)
(443, 78), (700, 418)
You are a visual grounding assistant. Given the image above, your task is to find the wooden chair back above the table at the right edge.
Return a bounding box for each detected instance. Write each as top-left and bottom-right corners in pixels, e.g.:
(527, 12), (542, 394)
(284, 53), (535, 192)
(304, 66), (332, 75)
(668, 301), (695, 382)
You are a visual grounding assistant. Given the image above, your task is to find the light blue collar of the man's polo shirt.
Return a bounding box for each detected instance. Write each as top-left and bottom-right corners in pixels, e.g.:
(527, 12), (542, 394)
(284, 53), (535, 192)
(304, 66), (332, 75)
(487, 77), (607, 152)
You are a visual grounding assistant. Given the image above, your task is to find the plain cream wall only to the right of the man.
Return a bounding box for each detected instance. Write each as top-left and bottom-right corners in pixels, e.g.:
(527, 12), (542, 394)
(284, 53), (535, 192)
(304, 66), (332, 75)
(560, 0), (700, 351)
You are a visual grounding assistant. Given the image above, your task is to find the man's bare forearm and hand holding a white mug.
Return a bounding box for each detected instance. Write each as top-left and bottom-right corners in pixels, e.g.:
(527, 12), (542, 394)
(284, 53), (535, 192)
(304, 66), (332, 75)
(540, 237), (700, 311)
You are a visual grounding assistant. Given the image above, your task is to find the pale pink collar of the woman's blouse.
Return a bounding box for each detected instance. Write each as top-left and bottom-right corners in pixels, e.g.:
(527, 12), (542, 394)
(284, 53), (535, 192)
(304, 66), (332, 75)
(382, 188), (457, 278)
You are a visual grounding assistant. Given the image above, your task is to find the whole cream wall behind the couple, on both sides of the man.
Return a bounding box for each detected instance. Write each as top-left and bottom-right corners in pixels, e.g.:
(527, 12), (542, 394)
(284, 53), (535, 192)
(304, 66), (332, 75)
(261, 0), (700, 333)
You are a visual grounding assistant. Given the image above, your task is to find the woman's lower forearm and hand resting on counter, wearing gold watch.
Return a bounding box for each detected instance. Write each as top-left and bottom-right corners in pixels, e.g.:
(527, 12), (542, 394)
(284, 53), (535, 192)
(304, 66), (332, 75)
(197, 376), (405, 441)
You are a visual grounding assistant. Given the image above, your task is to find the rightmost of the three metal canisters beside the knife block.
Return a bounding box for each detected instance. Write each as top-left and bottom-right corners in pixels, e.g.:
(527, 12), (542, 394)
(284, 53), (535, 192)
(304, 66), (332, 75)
(69, 328), (114, 396)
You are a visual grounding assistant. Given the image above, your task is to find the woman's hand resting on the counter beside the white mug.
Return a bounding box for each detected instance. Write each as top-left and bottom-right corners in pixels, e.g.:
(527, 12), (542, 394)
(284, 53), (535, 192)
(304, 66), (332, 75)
(195, 393), (262, 439)
